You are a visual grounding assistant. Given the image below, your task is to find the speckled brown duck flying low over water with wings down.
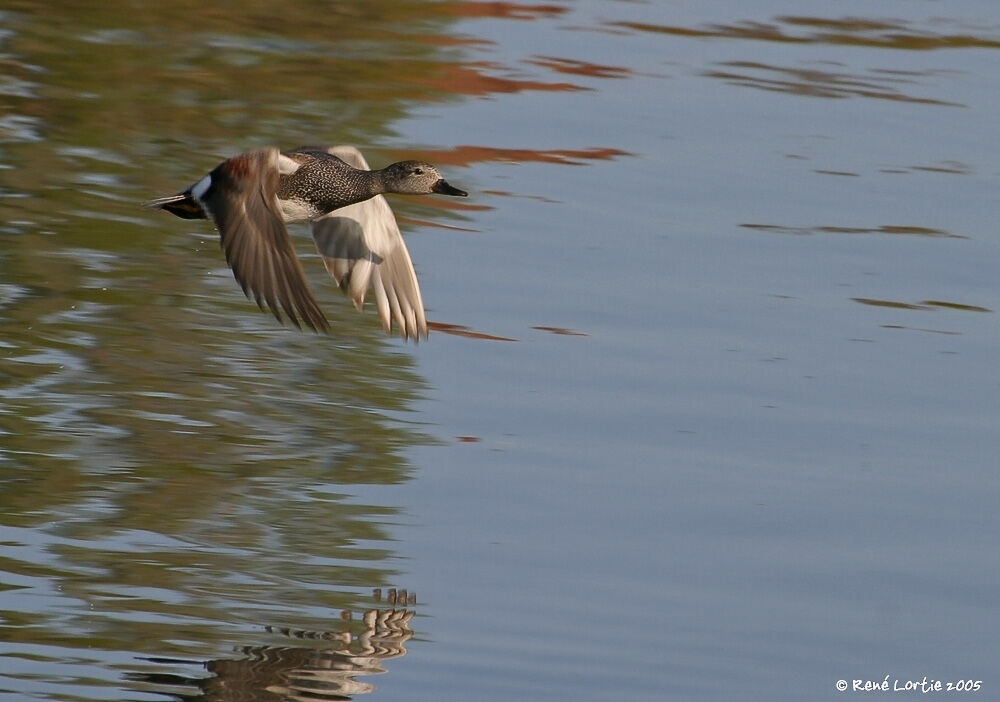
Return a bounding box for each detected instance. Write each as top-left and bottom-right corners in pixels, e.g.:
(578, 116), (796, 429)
(148, 146), (468, 341)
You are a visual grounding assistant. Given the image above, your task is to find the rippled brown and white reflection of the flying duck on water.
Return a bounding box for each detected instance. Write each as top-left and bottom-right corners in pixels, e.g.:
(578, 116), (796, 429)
(128, 589), (416, 702)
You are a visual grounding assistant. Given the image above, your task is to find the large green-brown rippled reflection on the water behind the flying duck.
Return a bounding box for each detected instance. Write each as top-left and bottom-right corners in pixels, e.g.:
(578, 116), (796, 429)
(0, 2), (464, 699)
